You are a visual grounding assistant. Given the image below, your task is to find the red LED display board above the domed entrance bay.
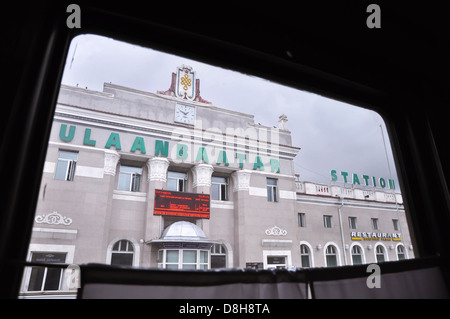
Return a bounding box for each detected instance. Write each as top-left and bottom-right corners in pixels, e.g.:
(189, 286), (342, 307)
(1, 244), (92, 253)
(153, 189), (210, 219)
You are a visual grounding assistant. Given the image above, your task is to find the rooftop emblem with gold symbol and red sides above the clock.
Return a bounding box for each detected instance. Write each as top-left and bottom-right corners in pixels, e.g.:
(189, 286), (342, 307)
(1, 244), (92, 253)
(157, 64), (211, 104)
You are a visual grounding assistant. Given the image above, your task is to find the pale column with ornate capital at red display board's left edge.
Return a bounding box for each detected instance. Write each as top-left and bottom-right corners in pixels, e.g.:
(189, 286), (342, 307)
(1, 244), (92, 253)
(142, 157), (169, 267)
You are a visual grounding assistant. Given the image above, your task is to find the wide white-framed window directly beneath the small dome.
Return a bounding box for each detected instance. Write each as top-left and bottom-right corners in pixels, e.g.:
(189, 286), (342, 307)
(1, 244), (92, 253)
(158, 249), (209, 269)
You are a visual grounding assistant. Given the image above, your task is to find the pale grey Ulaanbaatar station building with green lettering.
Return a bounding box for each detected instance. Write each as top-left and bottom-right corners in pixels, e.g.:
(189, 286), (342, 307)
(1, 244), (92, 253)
(22, 66), (414, 296)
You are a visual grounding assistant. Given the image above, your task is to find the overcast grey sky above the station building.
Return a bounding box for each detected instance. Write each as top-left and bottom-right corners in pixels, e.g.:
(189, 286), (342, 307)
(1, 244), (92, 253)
(62, 35), (400, 191)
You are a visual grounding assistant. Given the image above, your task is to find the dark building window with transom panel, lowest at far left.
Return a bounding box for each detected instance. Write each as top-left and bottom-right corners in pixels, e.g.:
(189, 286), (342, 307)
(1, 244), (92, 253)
(28, 252), (66, 291)
